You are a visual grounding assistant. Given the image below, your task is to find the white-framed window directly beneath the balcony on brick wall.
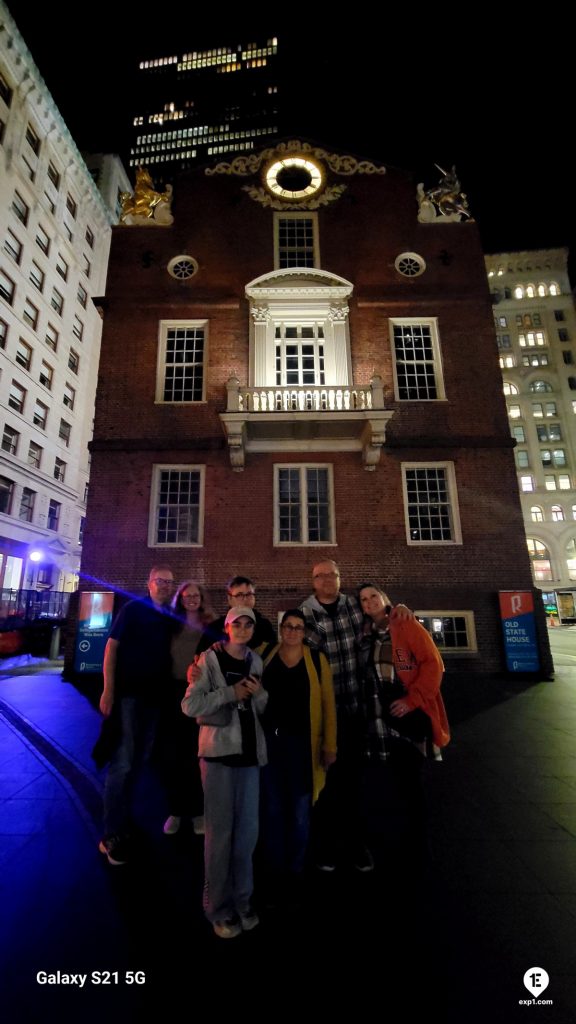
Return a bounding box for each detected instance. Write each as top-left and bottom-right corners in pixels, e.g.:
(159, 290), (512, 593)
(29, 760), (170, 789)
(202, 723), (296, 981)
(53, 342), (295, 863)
(275, 466), (335, 544)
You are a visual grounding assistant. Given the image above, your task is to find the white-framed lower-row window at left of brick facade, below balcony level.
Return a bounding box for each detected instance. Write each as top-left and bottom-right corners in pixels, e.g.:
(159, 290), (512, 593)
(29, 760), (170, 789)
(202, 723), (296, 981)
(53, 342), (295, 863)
(150, 466), (203, 546)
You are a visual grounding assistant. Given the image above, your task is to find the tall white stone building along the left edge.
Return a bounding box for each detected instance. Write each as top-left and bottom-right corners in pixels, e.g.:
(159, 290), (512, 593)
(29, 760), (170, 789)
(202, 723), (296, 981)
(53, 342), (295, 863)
(0, 0), (129, 591)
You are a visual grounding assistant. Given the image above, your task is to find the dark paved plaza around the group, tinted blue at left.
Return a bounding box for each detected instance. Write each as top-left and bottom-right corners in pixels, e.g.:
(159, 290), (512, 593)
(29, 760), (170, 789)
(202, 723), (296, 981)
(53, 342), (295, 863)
(0, 668), (576, 1024)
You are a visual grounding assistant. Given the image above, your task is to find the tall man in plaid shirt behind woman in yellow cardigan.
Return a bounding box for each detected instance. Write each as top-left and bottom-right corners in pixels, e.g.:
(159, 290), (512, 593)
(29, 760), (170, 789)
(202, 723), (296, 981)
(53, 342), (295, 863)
(301, 559), (374, 871)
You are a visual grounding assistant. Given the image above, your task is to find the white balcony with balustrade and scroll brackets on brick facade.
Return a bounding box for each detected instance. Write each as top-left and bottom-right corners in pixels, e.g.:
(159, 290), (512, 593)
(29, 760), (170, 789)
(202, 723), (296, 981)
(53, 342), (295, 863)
(220, 376), (394, 471)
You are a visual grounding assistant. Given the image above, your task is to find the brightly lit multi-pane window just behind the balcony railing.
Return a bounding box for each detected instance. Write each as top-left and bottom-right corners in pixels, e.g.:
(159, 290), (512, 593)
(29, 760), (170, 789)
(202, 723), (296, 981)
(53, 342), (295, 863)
(275, 324), (326, 386)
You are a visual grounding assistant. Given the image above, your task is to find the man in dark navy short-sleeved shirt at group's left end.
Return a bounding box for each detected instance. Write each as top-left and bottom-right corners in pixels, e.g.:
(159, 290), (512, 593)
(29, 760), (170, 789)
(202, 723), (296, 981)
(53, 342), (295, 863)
(99, 565), (174, 865)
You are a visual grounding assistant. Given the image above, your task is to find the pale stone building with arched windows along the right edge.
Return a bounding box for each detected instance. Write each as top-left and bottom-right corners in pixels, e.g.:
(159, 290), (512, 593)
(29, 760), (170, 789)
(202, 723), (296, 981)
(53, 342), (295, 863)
(486, 249), (576, 622)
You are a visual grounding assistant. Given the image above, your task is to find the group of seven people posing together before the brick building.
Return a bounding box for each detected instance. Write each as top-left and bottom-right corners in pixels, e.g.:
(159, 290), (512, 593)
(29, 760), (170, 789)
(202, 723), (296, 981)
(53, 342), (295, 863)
(99, 559), (449, 938)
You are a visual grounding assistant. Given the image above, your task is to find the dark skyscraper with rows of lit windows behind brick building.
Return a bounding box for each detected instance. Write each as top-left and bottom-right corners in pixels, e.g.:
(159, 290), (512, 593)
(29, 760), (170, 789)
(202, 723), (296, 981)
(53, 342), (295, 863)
(129, 38), (279, 180)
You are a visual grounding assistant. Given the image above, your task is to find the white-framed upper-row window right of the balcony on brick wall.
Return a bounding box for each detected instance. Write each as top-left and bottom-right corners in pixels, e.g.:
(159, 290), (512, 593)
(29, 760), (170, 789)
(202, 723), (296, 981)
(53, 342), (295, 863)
(390, 319), (444, 400)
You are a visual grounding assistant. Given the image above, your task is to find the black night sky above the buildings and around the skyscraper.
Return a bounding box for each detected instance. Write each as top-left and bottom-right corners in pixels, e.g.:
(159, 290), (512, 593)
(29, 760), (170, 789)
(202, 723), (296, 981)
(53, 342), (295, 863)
(8, 0), (576, 276)
